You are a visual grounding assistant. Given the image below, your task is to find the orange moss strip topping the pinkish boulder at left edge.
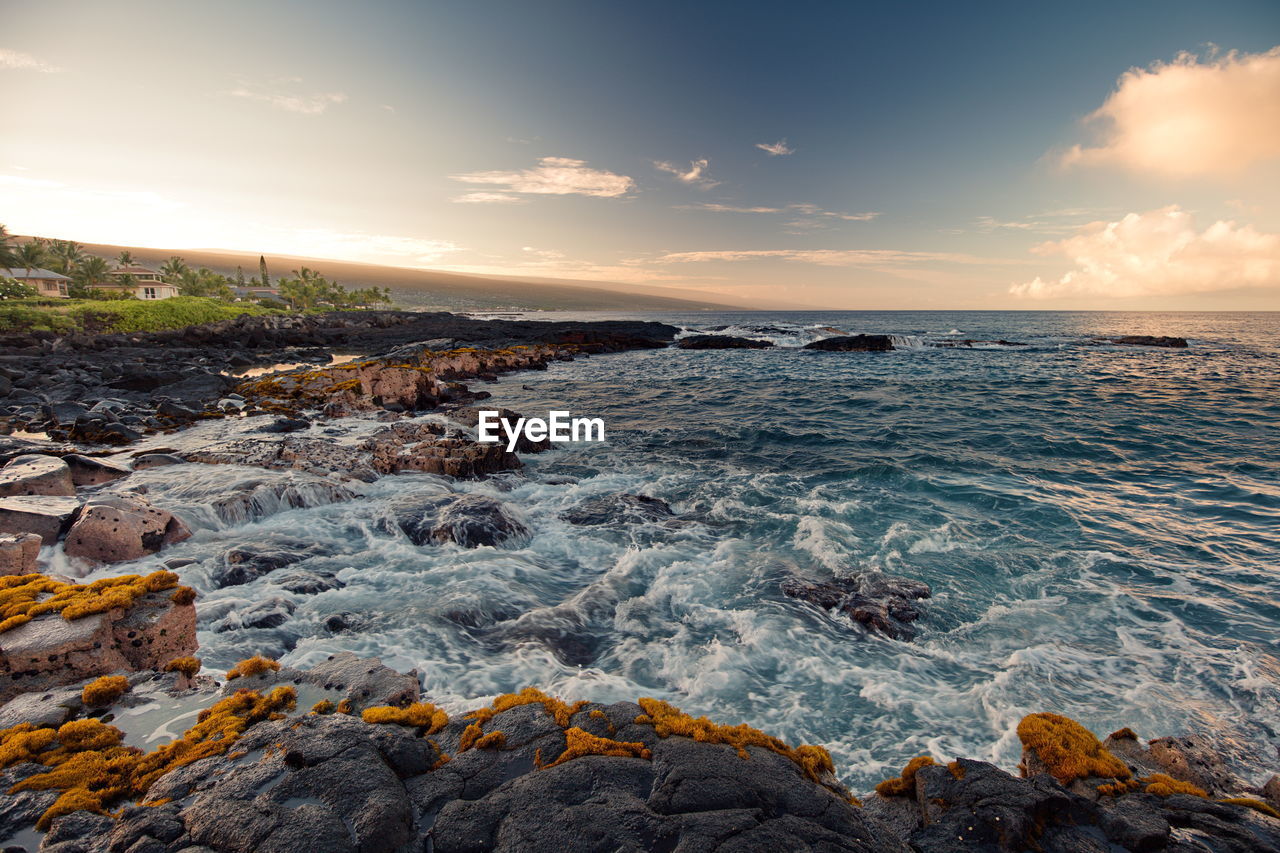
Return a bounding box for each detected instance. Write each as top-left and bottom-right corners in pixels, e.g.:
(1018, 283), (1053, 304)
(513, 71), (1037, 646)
(0, 571), (178, 633)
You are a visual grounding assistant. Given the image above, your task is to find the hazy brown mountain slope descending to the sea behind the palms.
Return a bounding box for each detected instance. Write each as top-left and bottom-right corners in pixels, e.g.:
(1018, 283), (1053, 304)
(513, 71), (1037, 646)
(52, 243), (758, 311)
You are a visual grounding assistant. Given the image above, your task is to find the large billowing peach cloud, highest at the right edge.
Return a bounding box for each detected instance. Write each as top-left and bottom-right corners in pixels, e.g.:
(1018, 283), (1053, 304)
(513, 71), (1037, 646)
(1061, 47), (1280, 178)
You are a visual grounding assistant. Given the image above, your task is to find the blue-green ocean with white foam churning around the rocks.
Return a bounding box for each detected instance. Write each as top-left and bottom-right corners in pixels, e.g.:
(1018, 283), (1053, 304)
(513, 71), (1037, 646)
(77, 311), (1280, 790)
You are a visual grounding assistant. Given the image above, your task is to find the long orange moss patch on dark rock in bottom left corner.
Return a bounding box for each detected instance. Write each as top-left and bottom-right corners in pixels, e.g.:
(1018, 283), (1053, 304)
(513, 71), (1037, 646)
(0, 686), (297, 830)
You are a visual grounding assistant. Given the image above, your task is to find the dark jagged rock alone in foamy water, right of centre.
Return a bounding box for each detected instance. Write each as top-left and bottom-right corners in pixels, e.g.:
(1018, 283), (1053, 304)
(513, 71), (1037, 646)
(782, 571), (932, 639)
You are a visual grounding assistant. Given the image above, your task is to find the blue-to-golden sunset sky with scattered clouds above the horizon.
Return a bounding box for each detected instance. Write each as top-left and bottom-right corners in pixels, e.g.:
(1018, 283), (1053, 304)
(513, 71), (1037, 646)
(0, 0), (1280, 310)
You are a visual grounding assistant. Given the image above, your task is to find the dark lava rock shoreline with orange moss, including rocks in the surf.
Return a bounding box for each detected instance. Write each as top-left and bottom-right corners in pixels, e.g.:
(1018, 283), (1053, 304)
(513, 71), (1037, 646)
(0, 313), (1264, 853)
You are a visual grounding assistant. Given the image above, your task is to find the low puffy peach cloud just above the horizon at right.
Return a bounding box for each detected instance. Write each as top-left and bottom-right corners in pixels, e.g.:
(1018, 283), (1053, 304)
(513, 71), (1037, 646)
(1009, 205), (1280, 298)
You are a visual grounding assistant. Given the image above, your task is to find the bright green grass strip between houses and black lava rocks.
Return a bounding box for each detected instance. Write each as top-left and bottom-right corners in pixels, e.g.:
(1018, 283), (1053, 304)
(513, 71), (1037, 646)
(0, 296), (283, 334)
